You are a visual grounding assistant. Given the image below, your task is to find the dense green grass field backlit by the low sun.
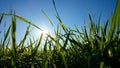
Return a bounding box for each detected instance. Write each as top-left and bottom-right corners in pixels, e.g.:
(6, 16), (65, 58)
(0, 0), (120, 68)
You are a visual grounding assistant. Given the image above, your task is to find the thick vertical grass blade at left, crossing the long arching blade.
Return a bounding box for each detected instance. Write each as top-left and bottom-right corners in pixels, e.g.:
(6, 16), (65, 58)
(11, 16), (16, 68)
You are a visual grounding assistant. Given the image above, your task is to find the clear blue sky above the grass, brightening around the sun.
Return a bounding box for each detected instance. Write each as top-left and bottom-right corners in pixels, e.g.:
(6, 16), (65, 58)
(0, 0), (117, 41)
